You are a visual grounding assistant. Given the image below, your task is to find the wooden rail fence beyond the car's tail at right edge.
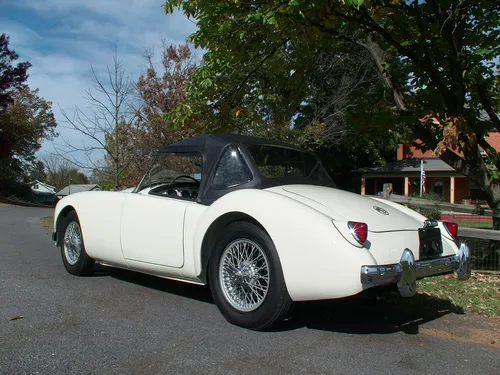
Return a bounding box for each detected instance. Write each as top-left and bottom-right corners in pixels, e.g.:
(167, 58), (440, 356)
(378, 194), (500, 272)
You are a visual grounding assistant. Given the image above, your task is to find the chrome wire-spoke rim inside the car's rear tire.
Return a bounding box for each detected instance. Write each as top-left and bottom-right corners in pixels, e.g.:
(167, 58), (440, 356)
(219, 239), (270, 312)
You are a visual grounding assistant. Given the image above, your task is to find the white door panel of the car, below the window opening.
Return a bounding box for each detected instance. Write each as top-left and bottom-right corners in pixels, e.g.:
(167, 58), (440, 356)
(121, 193), (196, 268)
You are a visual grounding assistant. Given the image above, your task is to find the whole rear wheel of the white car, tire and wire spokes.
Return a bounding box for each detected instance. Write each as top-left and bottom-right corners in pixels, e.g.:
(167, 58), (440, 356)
(209, 222), (292, 330)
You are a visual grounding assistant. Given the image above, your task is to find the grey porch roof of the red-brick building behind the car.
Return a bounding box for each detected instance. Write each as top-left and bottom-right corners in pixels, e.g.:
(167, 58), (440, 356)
(358, 158), (460, 175)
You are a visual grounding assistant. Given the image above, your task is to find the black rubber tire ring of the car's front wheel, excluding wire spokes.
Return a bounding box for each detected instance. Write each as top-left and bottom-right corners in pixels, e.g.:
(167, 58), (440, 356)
(58, 211), (95, 276)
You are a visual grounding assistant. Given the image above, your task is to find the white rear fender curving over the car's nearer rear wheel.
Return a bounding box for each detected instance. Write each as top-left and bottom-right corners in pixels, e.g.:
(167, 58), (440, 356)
(188, 189), (375, 300)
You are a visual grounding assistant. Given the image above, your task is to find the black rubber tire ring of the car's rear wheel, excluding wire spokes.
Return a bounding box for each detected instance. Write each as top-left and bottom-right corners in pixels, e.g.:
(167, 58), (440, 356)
(208, 221), (292, 330)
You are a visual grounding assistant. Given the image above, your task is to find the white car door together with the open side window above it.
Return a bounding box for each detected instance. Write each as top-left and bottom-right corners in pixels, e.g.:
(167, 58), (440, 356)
(121, 154), (202, 268)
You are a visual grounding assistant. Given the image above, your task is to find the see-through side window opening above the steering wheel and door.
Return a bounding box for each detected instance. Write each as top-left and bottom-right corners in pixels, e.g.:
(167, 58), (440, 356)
(137, 154), (202, 191)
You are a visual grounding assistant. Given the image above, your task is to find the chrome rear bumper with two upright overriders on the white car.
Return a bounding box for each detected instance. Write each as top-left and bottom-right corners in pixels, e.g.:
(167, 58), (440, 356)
(361, 244), (471, 297)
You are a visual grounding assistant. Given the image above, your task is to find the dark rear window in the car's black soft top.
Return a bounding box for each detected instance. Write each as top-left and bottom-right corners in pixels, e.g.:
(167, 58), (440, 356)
(248, 145), (333, 184)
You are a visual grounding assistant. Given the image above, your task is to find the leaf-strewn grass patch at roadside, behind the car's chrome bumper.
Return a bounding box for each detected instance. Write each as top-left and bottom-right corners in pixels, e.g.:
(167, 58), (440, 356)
(418, 272), (500, 318)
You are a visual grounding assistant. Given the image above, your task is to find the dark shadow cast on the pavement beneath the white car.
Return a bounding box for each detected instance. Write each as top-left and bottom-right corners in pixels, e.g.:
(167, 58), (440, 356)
(96, 266), (464, 334)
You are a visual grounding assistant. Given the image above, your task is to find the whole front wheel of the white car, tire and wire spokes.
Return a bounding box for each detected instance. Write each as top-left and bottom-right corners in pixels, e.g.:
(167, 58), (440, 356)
(60, 211), (95, 276)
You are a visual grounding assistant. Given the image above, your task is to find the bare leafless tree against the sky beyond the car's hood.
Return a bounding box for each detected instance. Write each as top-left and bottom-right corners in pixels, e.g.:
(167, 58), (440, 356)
(54, 51), (135, 189)
